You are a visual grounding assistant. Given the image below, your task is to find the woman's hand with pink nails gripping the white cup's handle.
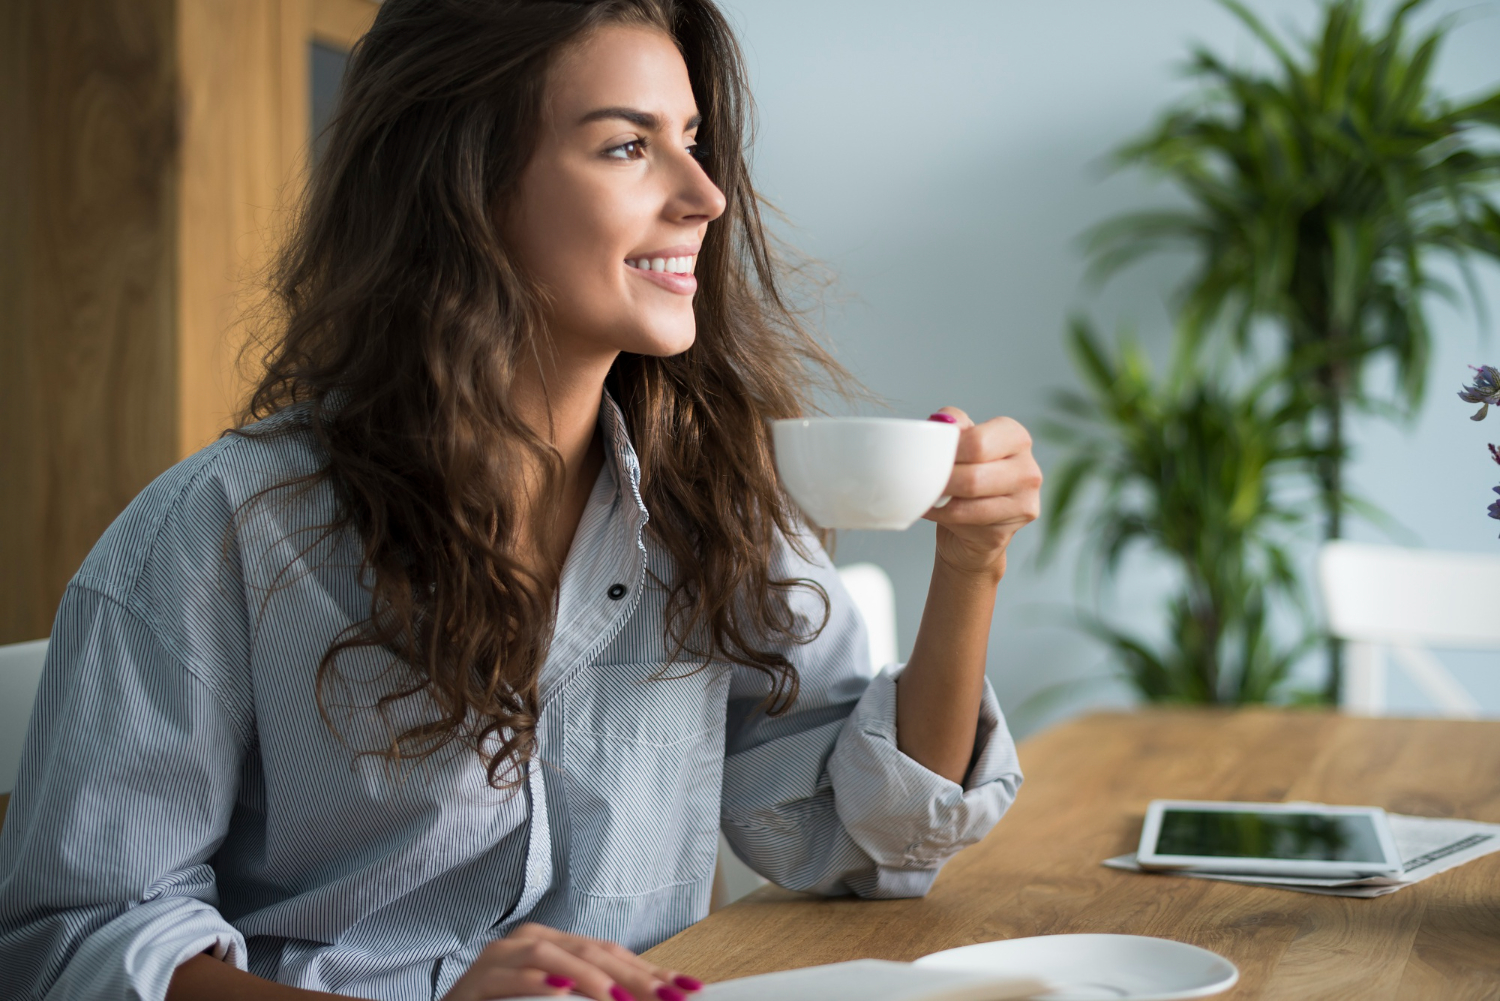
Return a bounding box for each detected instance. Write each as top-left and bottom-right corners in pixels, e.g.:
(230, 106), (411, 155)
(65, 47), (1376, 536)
(924, 407), (1041, 581)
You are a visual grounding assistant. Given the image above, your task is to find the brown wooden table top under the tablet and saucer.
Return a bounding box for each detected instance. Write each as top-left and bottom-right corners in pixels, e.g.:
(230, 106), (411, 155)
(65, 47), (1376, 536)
(647, 710), (1500, 1001)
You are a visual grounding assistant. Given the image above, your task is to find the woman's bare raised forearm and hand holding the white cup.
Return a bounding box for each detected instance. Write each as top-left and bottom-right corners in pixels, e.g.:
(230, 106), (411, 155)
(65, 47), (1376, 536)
(896, 407), (1041, 783)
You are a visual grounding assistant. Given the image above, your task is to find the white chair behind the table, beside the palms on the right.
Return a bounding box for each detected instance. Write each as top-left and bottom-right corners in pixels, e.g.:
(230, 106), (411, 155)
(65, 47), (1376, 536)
(1319, 542), (1500, 719)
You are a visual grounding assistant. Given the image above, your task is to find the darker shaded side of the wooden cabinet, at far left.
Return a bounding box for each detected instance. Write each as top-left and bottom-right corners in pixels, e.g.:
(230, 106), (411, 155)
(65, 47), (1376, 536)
(0, 0), (177, 641)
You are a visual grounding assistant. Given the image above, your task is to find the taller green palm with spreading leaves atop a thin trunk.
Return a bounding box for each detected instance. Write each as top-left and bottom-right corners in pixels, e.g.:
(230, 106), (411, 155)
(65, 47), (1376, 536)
(1089, 0), (1500, 699)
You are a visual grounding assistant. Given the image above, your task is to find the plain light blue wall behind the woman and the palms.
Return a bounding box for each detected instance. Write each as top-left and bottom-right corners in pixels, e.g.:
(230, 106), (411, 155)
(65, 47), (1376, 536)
(725, 0), (1500, 725)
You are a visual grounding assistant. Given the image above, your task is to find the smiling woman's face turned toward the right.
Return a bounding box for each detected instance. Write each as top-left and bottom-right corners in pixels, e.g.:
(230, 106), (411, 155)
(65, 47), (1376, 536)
(504, 26), (725, 360)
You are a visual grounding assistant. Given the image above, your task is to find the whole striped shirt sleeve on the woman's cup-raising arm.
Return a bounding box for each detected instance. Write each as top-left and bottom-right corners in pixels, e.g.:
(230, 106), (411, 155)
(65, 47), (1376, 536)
(722, 531), (1022, 897)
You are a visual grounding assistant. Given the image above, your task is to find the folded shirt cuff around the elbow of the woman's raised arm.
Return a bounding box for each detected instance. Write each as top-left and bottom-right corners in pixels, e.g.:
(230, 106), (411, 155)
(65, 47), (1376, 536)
(828, 665), (1022, 870)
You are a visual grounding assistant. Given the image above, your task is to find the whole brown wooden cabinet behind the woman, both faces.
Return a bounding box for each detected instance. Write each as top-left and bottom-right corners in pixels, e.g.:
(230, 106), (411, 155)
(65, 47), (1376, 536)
(0, 0), (378, 642)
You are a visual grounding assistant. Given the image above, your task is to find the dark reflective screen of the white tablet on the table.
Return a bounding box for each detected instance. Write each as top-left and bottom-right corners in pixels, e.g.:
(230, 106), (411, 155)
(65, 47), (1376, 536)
(1157, 809), (1385, 863)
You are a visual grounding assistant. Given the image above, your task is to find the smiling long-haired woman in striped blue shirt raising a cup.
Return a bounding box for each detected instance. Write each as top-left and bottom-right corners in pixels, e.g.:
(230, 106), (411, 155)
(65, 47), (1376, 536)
(0, 0), (1040, 1001)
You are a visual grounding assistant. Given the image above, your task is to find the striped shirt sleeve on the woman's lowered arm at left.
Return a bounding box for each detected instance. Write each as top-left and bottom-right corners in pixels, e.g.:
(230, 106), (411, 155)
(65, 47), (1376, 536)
(0, 584), (246, 999)
